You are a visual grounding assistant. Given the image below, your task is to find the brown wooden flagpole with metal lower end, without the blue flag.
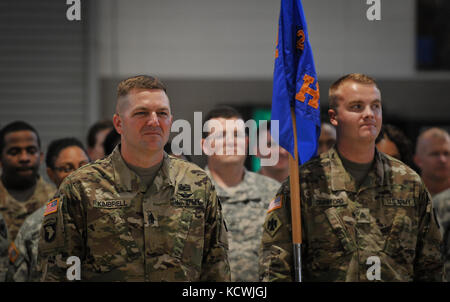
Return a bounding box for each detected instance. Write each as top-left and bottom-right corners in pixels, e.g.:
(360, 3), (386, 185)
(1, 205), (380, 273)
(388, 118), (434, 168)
(289, 107), (302, 282)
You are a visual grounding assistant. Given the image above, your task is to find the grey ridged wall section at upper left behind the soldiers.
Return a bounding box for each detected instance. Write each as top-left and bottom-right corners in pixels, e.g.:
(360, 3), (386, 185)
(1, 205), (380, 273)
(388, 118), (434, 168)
(0, 0), (98, 147)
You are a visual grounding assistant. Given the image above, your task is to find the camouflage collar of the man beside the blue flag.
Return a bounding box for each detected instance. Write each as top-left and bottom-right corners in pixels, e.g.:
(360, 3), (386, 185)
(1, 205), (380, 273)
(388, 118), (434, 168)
(327, 147), (384, 192)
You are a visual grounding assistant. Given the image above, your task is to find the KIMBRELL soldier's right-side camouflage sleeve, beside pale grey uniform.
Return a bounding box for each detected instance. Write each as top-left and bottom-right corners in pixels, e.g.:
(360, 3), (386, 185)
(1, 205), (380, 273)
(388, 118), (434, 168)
(200, 181), (231, 282)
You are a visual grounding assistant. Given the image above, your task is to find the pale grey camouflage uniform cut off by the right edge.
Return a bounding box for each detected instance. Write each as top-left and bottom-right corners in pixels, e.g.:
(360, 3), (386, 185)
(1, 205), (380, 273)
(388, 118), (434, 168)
(433, 189), (450, 282)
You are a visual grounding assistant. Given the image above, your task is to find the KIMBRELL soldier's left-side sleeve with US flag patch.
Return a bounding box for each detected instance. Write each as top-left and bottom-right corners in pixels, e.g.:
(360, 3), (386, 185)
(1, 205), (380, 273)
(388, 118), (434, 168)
(39, 177), (85, 281)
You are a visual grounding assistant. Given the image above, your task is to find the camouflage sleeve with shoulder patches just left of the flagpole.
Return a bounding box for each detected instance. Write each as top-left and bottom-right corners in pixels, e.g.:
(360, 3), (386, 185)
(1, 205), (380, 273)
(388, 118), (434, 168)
(259, 182), (294, 282)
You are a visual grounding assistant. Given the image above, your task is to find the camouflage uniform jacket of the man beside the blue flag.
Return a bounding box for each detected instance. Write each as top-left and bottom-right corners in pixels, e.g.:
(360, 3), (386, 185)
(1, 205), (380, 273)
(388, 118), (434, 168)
(260, 148), (442, 281)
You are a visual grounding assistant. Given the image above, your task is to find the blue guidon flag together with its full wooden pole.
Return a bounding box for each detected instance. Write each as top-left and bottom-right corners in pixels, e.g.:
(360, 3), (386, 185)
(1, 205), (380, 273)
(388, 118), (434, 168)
(256, 0), (320, 282)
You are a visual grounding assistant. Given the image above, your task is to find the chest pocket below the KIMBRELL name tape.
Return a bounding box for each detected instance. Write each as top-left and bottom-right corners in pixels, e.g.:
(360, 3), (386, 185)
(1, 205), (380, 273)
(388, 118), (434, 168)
(87, 209), (141, 272)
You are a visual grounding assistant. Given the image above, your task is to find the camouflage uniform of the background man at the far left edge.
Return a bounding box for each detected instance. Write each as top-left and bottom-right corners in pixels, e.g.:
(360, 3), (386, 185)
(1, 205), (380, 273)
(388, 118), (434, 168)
(0, 177), (56, 240)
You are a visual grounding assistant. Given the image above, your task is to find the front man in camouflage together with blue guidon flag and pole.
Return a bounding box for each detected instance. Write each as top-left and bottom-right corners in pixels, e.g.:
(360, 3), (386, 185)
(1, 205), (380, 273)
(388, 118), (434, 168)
(259, 0), (443, 282)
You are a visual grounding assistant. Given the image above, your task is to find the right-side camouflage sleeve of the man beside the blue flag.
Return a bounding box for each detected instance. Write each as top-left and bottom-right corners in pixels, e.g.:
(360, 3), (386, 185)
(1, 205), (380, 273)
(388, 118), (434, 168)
(414, 186), (443, 282)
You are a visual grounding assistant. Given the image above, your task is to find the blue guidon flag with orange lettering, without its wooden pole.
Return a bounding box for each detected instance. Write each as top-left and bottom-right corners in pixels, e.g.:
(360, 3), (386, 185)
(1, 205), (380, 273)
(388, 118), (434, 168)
(271, 0), (320, 164)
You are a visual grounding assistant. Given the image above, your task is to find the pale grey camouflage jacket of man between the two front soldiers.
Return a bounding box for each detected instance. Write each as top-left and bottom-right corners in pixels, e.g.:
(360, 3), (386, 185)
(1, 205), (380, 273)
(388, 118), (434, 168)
(205, 167), (280, 282)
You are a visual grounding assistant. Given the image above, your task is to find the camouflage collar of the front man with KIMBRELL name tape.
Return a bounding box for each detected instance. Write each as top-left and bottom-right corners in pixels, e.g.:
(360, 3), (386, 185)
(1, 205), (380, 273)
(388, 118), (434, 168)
(110, 144), (175, 192)
